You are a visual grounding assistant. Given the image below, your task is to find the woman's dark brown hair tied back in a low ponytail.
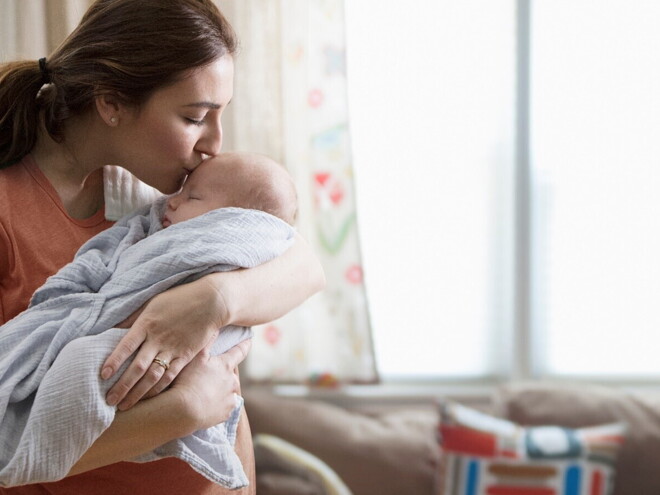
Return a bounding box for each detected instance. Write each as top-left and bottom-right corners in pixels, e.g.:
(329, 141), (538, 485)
(0, 0), (237, 168)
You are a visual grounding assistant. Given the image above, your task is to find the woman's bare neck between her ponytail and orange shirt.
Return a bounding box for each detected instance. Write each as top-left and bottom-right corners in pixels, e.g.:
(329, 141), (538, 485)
(31, 117), (103, 219)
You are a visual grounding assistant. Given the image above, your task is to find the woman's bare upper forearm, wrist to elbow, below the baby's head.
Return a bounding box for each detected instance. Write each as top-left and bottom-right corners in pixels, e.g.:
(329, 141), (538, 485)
(208, 234), (325, 326)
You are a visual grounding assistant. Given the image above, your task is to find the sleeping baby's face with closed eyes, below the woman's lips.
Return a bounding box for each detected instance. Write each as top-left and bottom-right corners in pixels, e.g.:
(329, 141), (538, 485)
(163, 160), (229, 227)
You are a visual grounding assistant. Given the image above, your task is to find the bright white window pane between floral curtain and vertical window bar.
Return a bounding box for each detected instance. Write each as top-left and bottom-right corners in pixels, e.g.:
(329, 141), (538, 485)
(345, 0), (515, 378)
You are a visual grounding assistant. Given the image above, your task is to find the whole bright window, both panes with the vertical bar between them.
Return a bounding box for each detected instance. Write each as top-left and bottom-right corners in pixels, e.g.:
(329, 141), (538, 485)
(345, 0), (660, 380)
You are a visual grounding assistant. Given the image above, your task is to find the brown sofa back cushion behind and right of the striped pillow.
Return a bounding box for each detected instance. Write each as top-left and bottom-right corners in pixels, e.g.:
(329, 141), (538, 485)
(494, 383), (660, 495)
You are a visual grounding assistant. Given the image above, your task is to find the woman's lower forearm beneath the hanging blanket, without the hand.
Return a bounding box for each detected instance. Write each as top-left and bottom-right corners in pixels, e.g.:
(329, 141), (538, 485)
(68, 390), (197, 476)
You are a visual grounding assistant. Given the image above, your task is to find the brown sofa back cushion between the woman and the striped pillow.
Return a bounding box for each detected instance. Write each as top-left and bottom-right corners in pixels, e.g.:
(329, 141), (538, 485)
(244, 391), (439, 495)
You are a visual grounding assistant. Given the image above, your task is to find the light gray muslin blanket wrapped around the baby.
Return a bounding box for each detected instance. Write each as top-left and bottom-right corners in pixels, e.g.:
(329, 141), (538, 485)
(0, 199), (294, 488)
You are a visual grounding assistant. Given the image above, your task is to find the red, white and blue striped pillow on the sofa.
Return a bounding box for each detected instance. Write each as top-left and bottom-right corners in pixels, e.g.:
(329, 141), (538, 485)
(439, 403), (626, 495)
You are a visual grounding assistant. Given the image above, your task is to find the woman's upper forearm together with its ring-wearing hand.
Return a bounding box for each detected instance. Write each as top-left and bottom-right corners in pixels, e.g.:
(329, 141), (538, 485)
(102, 235), (325, 410)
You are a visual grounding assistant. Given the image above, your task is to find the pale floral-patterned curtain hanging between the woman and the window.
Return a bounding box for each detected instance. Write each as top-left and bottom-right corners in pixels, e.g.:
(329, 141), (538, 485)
(218, 0), (377, 386)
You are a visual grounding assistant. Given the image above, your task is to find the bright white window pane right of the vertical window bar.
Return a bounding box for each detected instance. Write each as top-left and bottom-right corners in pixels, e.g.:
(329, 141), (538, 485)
(531, 0), (660, 377)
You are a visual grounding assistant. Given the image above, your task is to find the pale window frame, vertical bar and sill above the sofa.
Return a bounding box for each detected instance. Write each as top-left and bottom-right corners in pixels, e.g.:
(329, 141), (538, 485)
(284, 0), (660, 403)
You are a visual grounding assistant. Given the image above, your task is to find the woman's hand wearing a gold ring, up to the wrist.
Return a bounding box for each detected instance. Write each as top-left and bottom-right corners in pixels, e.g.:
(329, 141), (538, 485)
(101, 277), (228, 411)
